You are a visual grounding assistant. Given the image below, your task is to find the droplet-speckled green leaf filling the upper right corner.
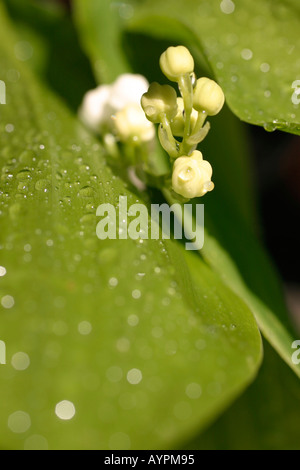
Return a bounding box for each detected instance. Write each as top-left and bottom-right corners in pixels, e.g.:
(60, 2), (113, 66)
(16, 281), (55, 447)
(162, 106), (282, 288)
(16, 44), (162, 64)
(128, 0), (300, 135)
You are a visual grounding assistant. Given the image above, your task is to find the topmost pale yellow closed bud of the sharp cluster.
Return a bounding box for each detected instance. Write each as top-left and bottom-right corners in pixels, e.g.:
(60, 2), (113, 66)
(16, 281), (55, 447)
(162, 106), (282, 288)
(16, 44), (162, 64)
(159, 46), (195, 82)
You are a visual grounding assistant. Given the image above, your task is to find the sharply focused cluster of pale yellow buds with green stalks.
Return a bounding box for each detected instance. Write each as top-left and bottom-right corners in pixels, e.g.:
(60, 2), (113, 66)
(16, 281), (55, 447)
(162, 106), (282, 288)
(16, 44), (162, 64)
(141, 46), (225, 199)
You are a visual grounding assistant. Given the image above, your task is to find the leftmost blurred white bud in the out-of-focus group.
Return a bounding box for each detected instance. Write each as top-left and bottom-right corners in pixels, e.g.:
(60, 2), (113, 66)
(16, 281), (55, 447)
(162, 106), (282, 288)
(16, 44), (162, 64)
(79, 85), (111, 132)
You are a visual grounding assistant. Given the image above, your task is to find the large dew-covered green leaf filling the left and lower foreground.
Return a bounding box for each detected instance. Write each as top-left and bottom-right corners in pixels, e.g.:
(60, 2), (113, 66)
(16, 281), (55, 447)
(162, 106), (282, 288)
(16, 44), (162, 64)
(0, 7), (261, 450)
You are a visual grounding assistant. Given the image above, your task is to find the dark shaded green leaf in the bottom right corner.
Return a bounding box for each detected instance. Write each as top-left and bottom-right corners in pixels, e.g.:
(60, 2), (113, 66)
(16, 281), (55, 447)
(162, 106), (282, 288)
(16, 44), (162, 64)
(188, 344), (300, 450)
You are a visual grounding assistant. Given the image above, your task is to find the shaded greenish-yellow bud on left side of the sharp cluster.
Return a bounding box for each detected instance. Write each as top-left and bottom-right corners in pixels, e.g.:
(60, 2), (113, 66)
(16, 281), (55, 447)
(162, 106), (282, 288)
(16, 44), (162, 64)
(141, 82), (177, 123)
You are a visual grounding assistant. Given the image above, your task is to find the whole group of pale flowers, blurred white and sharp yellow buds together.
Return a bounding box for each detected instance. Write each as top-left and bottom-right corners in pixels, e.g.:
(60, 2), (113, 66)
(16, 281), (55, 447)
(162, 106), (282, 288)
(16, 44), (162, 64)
(80, 46), (225, 200)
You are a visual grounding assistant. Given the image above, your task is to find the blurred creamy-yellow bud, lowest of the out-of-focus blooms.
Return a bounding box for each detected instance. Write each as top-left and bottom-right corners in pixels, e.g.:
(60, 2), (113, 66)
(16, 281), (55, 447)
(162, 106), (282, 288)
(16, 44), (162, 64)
(113, 103), (155, 143)
